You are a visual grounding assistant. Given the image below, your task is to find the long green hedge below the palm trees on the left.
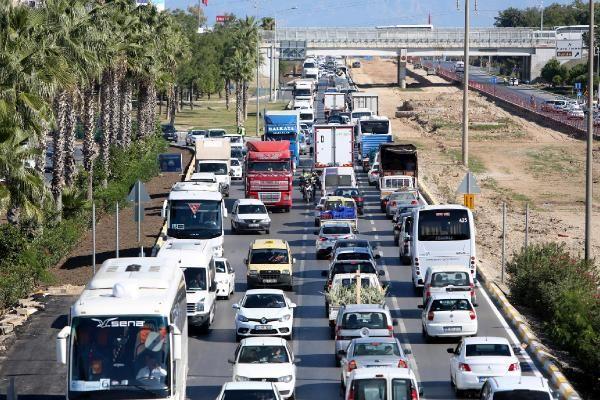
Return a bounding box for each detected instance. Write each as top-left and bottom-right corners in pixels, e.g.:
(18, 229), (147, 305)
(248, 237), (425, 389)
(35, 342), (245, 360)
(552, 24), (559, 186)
(0, 136), (167, 310)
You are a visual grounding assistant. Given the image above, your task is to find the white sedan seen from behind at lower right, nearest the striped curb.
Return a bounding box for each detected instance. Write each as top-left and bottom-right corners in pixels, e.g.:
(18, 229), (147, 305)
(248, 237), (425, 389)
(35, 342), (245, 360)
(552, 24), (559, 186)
(448, 337), (521, 397)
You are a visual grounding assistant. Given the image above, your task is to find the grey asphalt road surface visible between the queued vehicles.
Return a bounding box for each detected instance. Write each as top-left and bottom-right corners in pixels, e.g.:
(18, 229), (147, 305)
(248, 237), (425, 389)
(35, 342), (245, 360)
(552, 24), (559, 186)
(0, 76), (533, 400)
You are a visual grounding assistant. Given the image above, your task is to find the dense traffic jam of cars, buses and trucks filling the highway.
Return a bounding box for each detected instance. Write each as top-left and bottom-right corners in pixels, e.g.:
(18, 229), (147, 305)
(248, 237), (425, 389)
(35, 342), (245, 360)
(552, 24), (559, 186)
(56, 57), (553, 400)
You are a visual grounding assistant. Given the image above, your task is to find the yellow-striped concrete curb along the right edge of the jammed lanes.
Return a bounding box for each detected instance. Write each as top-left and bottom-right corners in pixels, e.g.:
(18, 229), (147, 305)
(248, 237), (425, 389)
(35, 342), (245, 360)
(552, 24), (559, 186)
(419, 182), (581, 400)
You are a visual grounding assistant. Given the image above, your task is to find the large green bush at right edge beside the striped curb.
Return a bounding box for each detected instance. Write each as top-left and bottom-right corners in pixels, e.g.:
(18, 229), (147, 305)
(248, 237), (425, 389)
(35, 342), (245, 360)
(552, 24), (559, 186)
(506, 243), (600, 389)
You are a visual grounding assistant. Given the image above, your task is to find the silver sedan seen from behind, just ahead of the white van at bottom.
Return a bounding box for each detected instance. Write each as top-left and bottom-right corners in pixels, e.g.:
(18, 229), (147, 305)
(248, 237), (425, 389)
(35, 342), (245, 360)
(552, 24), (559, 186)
(340, 337), (408, 390)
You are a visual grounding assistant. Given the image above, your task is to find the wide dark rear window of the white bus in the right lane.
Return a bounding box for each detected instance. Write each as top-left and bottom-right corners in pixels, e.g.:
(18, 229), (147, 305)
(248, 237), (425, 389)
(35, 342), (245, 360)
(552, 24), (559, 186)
(419, 209), (471, 242)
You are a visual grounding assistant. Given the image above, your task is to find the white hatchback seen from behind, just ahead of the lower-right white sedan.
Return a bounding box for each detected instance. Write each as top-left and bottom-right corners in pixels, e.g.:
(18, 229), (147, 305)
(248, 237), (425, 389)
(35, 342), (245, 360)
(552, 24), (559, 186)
(419, 292), (477, 340)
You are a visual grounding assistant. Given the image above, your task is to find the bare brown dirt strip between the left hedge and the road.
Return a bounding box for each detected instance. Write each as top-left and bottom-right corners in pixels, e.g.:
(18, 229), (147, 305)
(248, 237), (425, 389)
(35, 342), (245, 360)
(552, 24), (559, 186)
(50, 147), (192, 285)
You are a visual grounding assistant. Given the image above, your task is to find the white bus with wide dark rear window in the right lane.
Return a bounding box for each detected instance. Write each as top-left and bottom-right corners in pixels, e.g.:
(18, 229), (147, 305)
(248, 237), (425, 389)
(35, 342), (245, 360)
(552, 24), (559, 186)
(407, 204), (477, 288)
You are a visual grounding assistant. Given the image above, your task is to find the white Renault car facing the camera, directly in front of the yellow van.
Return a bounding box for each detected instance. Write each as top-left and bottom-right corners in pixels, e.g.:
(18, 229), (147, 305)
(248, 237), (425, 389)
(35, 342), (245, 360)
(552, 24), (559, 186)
(232, 289), (296, 340)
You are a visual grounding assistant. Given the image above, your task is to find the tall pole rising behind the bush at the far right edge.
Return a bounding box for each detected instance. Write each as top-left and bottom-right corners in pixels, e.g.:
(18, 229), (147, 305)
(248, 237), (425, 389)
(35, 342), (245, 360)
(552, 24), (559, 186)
(585, 0), (594, 260)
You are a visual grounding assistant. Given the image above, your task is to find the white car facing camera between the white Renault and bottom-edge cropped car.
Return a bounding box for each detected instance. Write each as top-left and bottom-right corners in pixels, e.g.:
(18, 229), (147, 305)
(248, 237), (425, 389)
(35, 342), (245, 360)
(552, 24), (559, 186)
(229, 337), (299, 399)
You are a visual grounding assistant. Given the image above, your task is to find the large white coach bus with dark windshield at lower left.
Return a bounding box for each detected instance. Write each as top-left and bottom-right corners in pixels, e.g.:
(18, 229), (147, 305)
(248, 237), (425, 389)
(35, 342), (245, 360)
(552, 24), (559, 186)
(56, 257), (188, 400)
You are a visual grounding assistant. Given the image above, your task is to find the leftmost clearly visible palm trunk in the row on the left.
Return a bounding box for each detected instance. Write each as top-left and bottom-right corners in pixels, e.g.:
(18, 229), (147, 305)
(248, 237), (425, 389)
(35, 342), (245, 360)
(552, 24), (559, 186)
(50, 91), (67, 221)
